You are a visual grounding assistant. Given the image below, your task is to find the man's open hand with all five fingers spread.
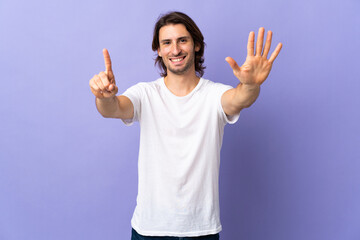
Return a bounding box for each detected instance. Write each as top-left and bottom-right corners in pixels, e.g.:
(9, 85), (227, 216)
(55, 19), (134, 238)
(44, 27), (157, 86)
(225, 27), (282, 86)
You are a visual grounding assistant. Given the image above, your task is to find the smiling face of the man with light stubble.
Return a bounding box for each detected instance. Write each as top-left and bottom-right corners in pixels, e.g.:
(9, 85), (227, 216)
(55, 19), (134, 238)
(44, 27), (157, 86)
(158, 24), (200, 75)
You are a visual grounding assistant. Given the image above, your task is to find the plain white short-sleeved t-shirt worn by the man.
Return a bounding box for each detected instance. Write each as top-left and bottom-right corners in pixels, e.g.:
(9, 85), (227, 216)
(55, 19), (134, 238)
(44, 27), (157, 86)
(123, 78), (239, 237)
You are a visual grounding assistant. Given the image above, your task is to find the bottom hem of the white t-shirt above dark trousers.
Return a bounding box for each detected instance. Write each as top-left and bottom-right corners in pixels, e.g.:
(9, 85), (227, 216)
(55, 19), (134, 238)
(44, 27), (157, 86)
(131, 223), (222, 237)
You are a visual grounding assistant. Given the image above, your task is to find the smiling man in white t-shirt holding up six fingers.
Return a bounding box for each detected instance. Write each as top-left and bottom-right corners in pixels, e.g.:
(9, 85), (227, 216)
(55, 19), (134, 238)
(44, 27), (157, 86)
(90, 12), (282, 239)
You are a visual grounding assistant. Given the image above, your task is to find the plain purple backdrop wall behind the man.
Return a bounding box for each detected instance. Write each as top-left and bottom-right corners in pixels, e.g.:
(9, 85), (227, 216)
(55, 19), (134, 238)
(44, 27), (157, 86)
(0, 0), (360, 240)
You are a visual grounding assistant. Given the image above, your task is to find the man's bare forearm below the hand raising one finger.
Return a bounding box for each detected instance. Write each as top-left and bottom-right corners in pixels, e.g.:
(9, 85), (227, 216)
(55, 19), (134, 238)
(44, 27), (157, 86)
(95, 96), (121, 118)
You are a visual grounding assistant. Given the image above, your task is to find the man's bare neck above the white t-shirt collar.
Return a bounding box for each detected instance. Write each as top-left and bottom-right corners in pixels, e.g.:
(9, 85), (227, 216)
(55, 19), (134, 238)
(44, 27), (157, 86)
(164, 71), (200, 97)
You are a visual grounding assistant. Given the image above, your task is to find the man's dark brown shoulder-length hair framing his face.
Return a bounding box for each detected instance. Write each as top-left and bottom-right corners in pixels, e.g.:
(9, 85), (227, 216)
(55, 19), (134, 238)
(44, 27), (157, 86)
(152, 12), (205, 77)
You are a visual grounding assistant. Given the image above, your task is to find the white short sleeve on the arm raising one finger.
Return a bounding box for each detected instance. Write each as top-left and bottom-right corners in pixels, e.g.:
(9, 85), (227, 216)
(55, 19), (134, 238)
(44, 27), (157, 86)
(122, 83), (143, 126)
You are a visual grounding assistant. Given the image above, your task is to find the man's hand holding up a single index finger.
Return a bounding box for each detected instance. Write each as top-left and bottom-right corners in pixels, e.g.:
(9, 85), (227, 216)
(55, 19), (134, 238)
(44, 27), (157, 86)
(89, 48), (118, 99)
